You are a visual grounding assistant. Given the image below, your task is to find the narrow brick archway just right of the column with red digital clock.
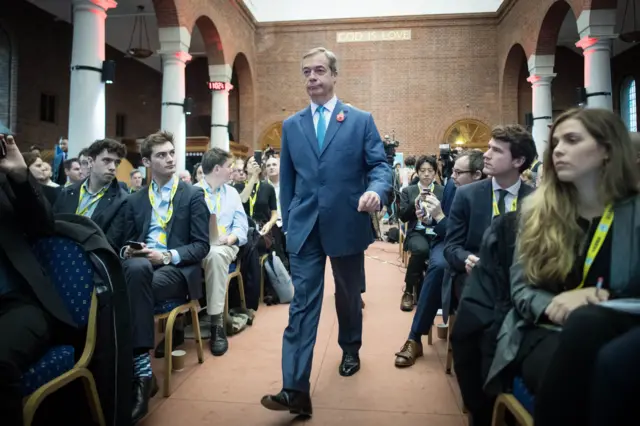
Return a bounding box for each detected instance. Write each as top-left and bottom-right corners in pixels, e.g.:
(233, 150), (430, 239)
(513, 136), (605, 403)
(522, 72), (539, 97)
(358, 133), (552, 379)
(233, 52), (256, 149)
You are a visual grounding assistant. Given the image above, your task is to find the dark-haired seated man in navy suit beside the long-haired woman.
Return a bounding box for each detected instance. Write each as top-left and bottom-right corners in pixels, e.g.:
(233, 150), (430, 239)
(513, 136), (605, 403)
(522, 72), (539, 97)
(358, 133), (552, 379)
(442, 124), (536, 425)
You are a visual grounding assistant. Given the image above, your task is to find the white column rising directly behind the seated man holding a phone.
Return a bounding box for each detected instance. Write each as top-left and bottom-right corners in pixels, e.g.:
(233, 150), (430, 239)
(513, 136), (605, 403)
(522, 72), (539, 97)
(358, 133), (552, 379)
(158, 27), (191, 171)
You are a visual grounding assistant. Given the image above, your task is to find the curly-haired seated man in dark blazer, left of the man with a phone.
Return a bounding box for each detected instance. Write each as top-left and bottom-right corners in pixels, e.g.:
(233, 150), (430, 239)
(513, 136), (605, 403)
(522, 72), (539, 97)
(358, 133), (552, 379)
(53, 139), (128, 250)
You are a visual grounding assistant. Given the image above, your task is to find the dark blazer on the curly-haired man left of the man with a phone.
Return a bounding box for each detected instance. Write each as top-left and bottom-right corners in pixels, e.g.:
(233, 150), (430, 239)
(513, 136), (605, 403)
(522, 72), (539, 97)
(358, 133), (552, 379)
(53, 179), (129, 250)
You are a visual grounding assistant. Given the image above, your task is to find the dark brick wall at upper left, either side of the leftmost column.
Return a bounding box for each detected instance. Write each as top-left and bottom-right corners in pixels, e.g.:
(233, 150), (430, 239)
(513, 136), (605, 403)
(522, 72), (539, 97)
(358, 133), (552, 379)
(0, 0), (162, 148)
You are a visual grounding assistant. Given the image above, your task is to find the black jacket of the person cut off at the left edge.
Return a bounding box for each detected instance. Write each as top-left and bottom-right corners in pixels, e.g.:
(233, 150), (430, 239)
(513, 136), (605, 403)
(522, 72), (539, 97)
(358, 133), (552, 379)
(0, 174), (75, 327)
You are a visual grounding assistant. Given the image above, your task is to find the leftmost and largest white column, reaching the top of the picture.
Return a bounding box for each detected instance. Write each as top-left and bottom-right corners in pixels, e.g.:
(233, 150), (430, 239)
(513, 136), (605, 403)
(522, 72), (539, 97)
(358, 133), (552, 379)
(68, 0), (117, 158)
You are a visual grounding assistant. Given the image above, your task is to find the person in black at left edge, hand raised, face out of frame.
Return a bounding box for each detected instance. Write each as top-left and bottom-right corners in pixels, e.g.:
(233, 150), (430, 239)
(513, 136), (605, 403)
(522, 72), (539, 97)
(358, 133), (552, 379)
(0, 135), (75, 425)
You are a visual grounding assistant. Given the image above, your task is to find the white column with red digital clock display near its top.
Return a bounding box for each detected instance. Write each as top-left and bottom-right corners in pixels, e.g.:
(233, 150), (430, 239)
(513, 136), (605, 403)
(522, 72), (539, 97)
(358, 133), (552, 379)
(209, 64), (233, 151)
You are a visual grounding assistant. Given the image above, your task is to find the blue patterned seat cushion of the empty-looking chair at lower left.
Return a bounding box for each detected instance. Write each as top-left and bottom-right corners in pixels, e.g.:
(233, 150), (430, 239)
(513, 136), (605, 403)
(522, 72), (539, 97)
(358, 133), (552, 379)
(22, 346), (75, 396)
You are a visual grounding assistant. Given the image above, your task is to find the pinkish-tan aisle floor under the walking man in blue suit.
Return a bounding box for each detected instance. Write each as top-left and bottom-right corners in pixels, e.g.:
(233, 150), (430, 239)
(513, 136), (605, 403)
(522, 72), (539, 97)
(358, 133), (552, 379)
(141, 243), (467, 426)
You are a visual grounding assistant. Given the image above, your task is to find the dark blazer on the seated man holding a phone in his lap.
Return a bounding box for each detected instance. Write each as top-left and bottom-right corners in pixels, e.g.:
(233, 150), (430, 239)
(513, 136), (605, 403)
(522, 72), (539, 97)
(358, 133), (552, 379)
(116, 177), (210, 300)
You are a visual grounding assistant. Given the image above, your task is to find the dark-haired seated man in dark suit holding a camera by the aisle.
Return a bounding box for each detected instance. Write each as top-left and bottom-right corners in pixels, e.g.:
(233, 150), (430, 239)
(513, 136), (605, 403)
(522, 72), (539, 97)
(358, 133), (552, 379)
(399, 155), (444, 312)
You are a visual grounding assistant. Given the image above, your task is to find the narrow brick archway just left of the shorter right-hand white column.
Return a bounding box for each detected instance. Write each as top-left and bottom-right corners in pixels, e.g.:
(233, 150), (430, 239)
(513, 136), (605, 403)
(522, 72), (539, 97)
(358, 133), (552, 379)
(500, 43), (527, 123)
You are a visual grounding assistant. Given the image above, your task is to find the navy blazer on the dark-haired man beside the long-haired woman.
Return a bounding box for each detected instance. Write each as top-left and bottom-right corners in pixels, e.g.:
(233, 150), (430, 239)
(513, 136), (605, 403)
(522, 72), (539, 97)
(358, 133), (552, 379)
(444, 179), (533, 273)
